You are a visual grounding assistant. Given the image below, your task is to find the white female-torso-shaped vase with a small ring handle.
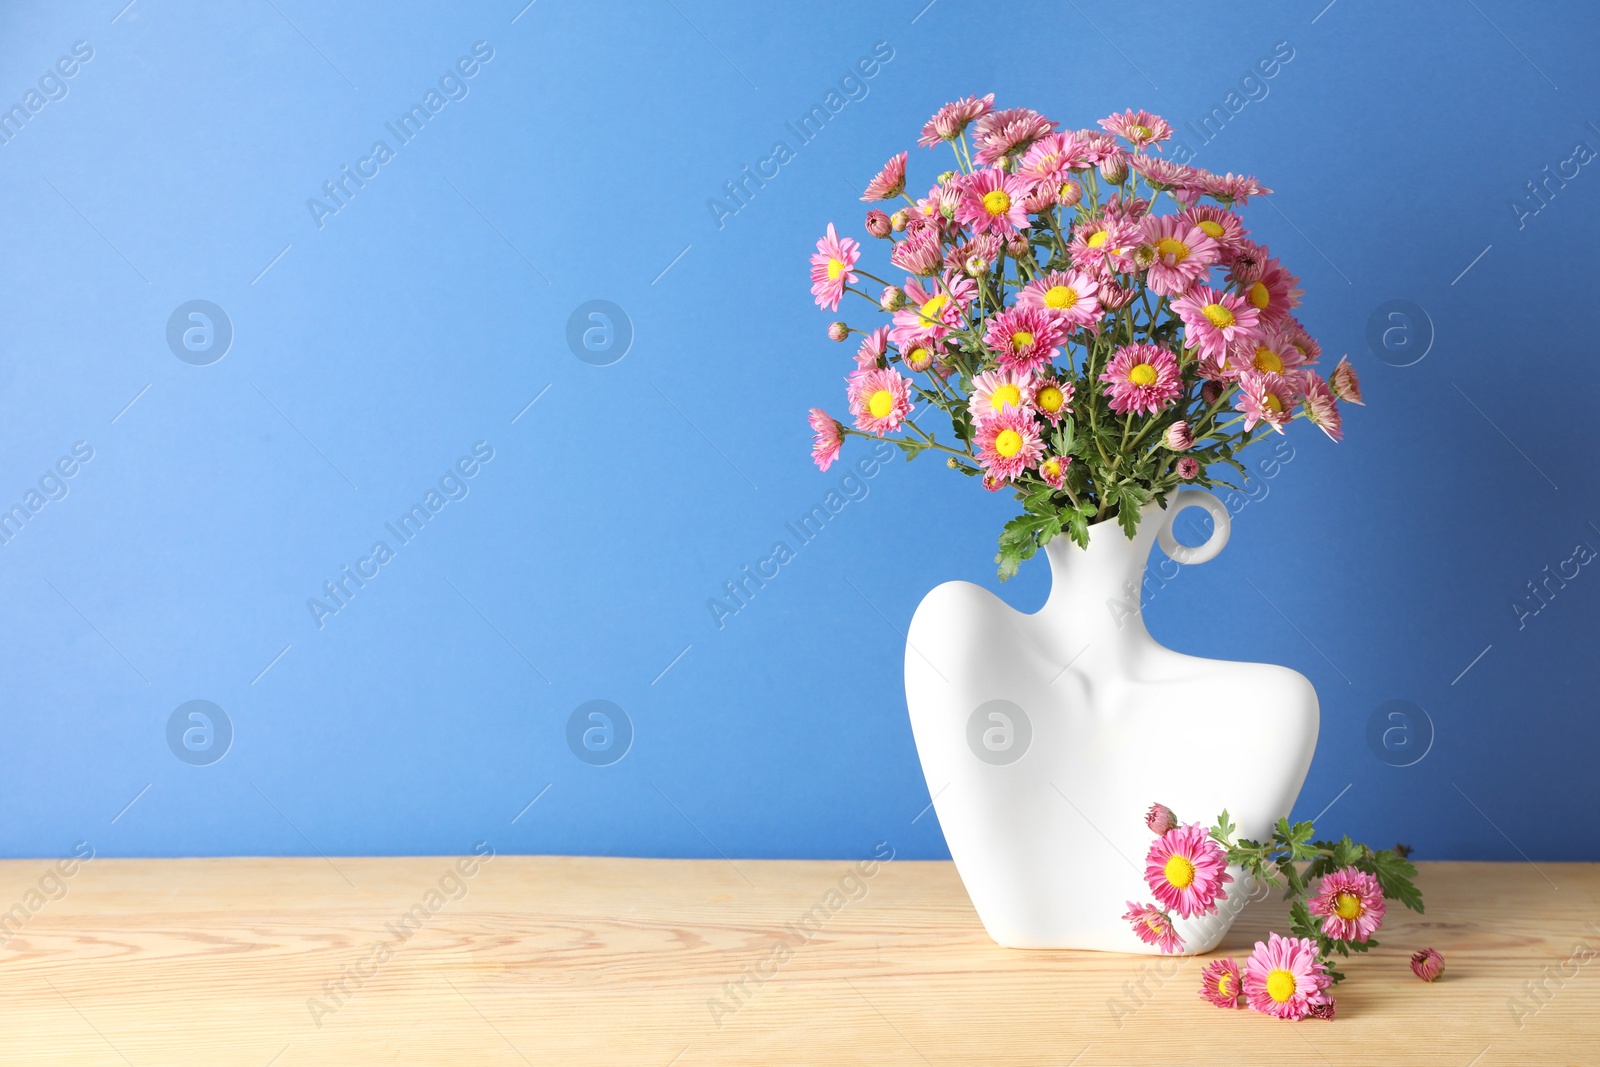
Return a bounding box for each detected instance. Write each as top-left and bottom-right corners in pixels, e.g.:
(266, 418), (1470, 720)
(906, 490), (1318, 953)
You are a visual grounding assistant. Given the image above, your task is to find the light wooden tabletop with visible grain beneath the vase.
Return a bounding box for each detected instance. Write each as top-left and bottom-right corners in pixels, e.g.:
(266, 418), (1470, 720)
(0, 856), (1600, 1067)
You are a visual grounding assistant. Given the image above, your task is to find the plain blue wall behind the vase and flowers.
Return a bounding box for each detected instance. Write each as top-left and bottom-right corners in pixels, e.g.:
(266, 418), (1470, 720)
(0, 0), (1600, 861)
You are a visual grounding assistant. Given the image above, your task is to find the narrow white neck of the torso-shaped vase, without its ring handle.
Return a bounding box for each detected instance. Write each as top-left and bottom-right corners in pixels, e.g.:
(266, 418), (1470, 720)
(1038, 504), (1162, 656)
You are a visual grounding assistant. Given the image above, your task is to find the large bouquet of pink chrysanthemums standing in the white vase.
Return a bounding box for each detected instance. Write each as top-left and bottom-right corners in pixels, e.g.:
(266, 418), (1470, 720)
(810, 94), (1362, 579)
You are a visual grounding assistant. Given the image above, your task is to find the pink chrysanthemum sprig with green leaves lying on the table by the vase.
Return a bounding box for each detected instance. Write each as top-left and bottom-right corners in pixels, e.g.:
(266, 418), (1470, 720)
(1123, 805), (1443, 1019)
